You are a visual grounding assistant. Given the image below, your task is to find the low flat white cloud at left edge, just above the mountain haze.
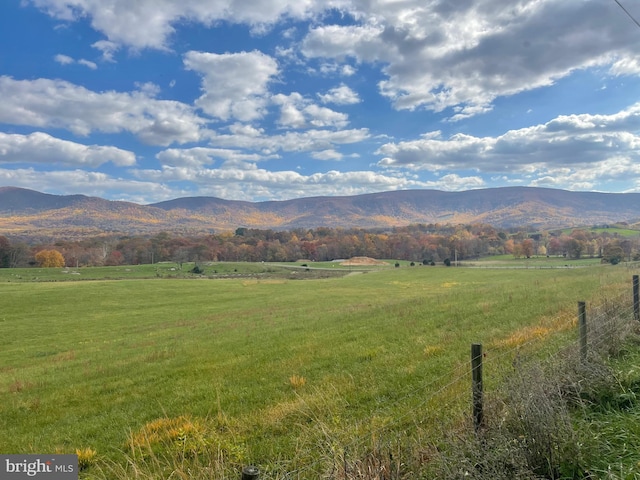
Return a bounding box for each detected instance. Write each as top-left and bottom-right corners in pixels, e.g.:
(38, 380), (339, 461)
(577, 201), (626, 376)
(0, 132), (136, 167)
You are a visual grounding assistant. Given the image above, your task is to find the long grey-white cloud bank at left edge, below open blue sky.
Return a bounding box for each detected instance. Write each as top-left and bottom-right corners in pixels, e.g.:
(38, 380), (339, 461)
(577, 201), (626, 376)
(0, 76), (205, 146)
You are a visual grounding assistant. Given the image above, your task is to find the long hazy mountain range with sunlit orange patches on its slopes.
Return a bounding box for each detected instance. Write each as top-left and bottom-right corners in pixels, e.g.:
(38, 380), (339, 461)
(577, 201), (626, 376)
(0, 187), (640, 238)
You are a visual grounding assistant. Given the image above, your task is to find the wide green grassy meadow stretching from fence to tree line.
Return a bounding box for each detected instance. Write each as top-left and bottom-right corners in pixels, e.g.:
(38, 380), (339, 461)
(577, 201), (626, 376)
(0, 264), (637, 478)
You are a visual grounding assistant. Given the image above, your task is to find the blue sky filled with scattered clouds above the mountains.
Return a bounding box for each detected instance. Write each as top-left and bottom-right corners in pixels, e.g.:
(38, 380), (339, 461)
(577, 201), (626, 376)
(0, 0), (640, 204)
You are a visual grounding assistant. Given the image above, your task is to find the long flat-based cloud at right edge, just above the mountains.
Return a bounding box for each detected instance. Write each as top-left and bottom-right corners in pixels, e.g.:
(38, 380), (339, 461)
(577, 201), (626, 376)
(376, 103), (640, 188)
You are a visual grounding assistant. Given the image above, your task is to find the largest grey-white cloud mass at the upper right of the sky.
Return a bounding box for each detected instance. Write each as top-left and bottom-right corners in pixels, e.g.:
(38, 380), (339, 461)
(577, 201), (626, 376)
(302, 0), (640, 116)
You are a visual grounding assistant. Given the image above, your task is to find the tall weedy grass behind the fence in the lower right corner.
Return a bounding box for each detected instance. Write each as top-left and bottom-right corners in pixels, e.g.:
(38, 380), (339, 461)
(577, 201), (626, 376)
(427, 288), (640, 480)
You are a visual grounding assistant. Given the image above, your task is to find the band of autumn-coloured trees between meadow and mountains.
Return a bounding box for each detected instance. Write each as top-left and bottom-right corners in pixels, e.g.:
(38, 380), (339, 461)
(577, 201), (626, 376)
(0, 224), (640, 267)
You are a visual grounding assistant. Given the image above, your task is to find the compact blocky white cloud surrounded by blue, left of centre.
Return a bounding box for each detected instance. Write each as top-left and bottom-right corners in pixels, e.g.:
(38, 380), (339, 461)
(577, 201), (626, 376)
(184, 51), (278, 121)
